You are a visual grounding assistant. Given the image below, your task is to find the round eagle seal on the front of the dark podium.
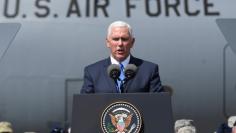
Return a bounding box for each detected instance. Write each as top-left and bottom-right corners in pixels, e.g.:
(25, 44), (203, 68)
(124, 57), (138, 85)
(101, 102), (142, 133)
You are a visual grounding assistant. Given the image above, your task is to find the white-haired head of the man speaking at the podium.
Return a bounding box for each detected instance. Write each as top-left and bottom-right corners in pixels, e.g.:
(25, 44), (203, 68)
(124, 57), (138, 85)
(106, 21), (135, 62)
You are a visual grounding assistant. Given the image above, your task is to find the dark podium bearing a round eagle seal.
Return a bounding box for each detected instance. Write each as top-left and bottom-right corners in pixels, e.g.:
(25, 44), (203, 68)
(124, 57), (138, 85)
(71, 93), (174, 133)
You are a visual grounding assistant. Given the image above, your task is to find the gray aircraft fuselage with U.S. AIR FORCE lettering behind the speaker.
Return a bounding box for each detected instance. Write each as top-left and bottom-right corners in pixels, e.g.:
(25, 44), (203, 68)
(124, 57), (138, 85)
(0, 0), (236, 133)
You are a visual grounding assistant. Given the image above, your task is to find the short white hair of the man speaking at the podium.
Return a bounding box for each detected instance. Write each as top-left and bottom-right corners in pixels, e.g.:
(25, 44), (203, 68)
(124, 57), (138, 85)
(107, 21), (134, 38)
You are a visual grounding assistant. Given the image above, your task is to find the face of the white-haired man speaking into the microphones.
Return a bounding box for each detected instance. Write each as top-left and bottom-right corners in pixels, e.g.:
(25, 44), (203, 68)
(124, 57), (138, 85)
(106, 27), (134, 62)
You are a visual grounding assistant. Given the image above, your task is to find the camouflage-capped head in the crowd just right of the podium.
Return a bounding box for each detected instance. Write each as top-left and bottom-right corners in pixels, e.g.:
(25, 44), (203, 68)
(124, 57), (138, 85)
(175, 119), (196, 133)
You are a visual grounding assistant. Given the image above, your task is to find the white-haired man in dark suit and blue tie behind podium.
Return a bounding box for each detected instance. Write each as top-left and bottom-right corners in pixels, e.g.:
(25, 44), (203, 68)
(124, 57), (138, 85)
(81, 21), (163, 93)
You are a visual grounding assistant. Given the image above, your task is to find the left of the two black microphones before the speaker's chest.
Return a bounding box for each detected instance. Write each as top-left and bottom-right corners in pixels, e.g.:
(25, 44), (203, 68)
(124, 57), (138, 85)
(107, 64), (120, 80)
